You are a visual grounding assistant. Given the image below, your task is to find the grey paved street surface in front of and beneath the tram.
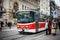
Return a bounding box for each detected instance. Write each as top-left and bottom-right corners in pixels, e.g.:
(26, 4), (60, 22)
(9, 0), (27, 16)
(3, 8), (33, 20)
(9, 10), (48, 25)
(0, 27), (60, 40)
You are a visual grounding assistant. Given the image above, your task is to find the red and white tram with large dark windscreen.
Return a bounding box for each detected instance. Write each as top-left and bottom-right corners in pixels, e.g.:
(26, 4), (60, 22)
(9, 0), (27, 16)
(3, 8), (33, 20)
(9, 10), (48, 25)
(16, 10), (46, 33)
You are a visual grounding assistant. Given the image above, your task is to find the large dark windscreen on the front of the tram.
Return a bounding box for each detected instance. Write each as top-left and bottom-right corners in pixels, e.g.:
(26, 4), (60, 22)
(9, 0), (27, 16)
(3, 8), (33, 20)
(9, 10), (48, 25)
(17, 11), (33, 23)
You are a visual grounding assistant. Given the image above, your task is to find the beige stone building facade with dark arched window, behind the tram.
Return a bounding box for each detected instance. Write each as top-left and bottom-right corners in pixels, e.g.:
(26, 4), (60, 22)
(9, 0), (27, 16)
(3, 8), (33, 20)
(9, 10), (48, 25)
(3, 0), (39, 20)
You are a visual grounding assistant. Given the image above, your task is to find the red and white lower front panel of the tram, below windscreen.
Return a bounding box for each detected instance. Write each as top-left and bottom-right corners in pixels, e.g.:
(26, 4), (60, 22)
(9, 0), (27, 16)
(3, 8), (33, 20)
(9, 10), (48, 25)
(17, 22), (36, 33)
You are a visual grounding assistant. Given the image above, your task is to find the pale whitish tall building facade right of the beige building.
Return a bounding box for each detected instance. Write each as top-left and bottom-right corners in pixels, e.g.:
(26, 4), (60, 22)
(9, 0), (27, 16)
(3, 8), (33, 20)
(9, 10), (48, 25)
(40, 0), (50, 16)
